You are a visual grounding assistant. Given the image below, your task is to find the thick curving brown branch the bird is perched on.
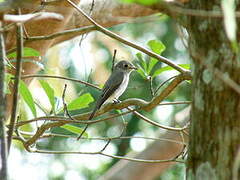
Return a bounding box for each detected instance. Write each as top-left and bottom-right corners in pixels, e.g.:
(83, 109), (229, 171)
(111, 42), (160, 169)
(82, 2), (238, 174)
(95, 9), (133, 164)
(16, 74), (191, 149)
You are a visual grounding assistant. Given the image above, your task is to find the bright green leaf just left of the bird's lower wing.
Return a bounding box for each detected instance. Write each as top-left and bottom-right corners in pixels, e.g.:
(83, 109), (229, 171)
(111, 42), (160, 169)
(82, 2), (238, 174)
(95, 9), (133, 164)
(67, 93), (94, 111)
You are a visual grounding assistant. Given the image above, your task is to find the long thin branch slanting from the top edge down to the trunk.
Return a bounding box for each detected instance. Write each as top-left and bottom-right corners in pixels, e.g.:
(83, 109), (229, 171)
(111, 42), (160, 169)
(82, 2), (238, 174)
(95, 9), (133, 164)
(66, 0), (189, 73)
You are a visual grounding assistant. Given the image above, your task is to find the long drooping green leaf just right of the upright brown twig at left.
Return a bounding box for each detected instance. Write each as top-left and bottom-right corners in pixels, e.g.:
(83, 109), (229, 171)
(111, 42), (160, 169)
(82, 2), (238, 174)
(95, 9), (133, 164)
(19, 80), (37, 117)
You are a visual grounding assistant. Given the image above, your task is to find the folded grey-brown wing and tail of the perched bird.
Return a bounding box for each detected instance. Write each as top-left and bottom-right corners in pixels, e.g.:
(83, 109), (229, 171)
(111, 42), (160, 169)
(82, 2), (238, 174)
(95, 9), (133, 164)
(89, 71), (124, 120)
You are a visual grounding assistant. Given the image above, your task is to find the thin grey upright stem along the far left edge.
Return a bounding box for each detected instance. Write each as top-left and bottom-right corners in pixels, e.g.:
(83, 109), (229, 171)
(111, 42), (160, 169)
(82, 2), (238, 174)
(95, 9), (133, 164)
(0, 21), (8, 180)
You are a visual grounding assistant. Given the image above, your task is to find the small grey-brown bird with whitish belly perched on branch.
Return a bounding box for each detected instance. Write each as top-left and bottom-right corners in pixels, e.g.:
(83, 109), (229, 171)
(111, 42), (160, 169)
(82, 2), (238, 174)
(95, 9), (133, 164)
(89, 61), (137, 120)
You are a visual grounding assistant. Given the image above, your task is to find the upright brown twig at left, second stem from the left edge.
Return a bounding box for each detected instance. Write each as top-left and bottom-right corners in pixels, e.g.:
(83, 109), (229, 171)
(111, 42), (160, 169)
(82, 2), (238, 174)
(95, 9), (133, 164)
(7, 20), (23, 151)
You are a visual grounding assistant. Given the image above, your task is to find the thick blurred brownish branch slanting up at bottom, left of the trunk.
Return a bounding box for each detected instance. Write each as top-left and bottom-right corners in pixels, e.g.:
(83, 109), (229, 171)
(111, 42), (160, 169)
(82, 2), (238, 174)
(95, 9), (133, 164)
(99, 132), (187, 180)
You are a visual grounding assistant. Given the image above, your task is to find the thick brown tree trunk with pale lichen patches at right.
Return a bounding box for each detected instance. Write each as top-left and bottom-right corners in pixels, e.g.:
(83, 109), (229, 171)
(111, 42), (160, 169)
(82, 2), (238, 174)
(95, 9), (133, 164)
(187, 0), (240, 180)
